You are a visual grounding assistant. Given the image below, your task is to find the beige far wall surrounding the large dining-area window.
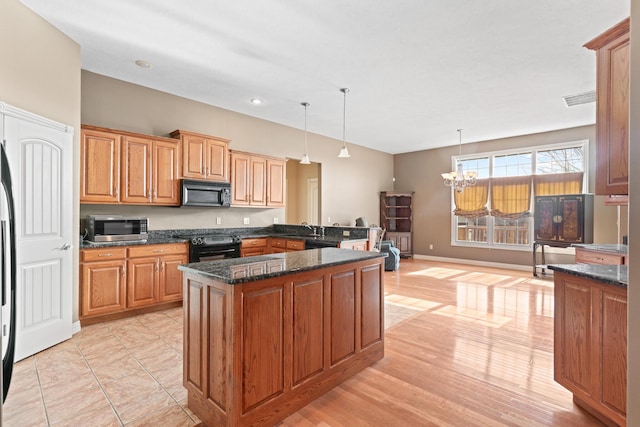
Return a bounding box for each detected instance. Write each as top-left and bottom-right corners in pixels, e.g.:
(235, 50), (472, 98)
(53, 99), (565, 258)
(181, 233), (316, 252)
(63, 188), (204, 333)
(394, 126), (618, 265)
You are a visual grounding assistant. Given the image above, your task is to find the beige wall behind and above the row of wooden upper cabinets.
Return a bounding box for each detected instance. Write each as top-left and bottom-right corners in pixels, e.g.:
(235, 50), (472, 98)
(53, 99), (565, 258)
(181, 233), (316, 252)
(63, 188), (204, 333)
(81, 71), (393, 229)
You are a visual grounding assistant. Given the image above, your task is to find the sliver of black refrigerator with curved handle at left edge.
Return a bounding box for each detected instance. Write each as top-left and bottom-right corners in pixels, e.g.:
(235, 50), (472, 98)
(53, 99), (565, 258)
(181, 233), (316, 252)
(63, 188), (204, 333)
(0, 144), (16, 416)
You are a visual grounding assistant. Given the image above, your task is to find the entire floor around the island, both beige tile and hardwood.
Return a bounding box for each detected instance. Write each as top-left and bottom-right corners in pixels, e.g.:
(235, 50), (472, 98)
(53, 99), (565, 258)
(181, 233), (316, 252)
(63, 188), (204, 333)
(2, 260), (601, 427)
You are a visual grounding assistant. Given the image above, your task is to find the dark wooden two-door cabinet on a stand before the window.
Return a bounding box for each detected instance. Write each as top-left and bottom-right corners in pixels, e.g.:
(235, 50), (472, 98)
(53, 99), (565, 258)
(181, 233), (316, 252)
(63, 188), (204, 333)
(534, 194), (593, 247)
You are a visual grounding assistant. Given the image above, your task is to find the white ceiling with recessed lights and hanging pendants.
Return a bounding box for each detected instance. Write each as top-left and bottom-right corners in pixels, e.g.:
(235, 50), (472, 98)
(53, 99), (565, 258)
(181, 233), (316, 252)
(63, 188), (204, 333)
(22, 0), (630, 154)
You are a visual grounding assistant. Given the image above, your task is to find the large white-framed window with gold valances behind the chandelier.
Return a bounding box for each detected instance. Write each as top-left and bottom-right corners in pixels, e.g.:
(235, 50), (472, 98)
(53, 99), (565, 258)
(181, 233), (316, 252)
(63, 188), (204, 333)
(452, 141), (588, 250)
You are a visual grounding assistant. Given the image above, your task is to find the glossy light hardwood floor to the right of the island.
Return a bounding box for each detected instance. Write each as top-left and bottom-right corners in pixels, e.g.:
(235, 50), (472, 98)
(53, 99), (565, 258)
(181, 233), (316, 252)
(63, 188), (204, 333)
(281, 260), (601, 427)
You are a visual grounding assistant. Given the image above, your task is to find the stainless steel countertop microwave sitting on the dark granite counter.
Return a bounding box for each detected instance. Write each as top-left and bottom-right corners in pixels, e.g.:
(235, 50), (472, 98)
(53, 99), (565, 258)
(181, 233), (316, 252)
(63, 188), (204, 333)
(85, 215), (149, 242)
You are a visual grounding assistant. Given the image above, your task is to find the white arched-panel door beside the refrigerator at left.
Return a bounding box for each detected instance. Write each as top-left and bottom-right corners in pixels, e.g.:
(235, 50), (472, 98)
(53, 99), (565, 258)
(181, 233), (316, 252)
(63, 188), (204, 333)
(4, 110), (77, 361)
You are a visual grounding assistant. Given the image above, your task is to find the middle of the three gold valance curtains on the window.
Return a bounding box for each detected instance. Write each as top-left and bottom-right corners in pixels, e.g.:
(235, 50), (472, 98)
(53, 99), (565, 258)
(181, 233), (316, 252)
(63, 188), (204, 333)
(491, 175), (532, 219)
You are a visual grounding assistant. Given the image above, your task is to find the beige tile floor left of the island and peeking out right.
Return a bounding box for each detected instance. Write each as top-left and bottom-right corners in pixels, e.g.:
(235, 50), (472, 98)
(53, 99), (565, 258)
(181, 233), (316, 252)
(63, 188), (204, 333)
(2, 295), (410, 427)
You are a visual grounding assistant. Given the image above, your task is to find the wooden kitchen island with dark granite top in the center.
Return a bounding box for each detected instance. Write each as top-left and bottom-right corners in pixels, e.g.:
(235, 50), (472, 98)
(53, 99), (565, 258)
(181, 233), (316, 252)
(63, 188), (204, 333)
(179, 248), (385, 426)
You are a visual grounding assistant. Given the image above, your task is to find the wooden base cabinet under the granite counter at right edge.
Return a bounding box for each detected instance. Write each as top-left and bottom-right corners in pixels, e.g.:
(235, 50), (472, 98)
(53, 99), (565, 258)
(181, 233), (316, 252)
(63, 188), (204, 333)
(554, 271), (627, 425)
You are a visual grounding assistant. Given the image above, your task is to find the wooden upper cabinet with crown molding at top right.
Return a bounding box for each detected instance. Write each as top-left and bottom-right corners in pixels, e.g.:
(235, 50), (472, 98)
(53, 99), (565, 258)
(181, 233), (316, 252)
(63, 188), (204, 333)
(584, 18), (630, 195)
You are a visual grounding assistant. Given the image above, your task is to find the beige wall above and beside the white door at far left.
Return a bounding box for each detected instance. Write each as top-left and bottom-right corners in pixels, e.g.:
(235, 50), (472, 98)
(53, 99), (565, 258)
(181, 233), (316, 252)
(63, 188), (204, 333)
(0, 0), (80, 321)
